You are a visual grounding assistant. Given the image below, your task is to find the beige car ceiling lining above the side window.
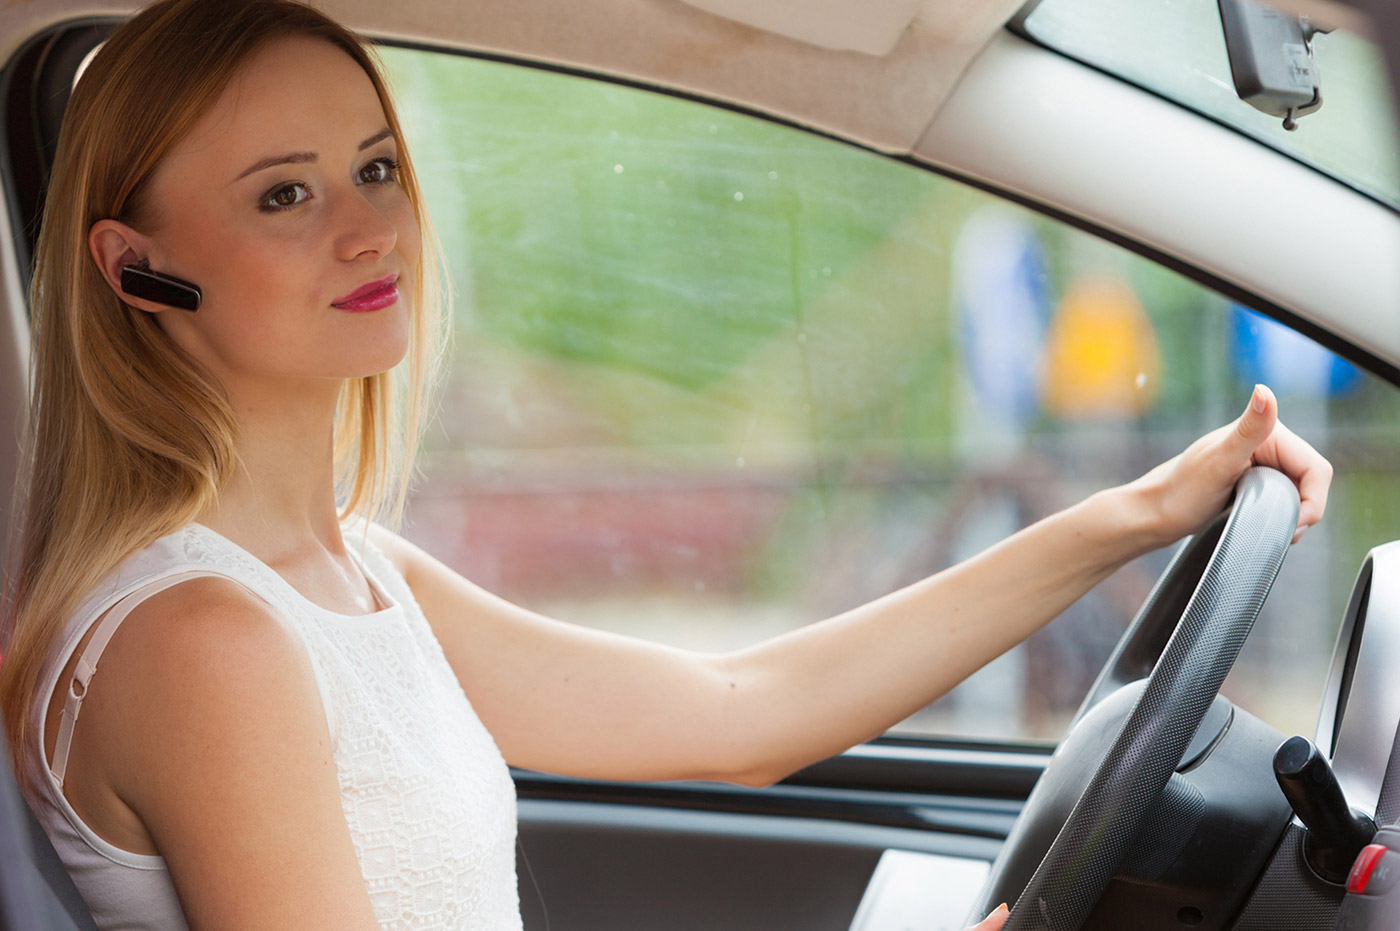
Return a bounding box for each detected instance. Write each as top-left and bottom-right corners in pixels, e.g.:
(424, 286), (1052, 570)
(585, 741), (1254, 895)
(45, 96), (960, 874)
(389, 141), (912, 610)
(0, 0), (1021, 153)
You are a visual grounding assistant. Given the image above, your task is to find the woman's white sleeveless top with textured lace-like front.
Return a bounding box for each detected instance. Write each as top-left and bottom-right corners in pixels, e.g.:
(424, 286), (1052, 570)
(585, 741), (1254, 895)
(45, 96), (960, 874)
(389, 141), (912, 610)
(25, 524), (521, 931)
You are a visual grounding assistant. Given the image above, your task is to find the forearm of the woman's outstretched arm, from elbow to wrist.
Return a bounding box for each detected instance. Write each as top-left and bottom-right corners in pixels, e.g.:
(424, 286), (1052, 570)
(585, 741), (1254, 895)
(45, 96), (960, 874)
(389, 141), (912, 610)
(727, 478), (1152, 783)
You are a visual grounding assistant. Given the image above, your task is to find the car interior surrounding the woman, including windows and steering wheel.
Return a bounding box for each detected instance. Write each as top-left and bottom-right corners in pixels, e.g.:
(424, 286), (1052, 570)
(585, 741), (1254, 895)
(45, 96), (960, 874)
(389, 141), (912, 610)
(0, 0), (1400, 931)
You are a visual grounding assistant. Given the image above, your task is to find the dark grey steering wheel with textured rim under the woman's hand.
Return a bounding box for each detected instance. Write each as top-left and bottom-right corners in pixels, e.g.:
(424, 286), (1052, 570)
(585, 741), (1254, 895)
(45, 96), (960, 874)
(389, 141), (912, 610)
(969, 466), (1298, 931)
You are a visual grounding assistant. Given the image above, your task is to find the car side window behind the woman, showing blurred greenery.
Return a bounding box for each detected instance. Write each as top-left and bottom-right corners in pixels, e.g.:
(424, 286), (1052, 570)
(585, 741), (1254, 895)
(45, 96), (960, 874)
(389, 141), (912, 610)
(384, 48), (1400, 741)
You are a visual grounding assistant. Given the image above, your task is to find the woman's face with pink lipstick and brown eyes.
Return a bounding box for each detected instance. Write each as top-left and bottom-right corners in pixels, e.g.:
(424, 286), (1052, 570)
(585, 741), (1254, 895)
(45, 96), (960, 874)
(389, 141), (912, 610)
(108, 38), (419, 395)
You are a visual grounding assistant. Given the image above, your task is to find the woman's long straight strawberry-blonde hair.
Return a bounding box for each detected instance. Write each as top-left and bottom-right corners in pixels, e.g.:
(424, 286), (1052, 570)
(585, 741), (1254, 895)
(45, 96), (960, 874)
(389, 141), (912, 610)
(0, 0), (447, 783)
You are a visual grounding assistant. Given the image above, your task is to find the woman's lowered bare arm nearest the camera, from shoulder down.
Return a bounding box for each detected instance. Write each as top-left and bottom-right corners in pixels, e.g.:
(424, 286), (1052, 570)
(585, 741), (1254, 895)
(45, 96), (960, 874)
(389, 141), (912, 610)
(90, 580), (379, 931)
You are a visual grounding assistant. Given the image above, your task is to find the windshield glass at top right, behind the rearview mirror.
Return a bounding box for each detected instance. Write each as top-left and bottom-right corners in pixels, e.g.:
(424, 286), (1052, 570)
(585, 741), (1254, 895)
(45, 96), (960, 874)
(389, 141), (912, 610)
(1025, 0), (1400, 207)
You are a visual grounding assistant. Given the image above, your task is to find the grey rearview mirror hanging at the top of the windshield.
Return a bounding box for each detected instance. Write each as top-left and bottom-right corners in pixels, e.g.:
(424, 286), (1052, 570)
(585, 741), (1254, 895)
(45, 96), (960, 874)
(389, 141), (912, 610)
(1218, 0), (1329, 130)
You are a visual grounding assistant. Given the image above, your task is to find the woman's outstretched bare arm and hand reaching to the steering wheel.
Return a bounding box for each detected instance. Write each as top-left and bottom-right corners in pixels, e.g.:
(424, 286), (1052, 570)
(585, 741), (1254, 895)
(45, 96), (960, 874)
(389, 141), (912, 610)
(384, 391), (1331, 785)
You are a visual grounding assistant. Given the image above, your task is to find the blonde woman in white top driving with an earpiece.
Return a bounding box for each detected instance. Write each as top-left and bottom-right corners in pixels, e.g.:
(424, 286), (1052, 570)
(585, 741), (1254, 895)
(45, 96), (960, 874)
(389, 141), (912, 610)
(0, 0), (1331, 930)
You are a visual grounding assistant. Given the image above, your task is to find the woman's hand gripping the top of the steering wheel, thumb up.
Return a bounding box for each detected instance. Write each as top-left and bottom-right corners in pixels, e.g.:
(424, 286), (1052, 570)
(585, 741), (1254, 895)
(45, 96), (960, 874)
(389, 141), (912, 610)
(1130, 385), (1331, 546)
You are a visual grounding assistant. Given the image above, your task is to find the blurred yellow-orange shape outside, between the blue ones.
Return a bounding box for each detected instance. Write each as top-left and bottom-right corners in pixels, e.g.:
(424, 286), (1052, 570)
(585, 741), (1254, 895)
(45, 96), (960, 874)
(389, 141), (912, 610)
(1043, 277), (1162, 419)
